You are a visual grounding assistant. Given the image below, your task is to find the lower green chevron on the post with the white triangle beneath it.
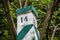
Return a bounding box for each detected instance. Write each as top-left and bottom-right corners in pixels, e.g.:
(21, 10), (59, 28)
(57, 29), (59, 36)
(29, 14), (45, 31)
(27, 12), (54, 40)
(17, 24), (40, 40)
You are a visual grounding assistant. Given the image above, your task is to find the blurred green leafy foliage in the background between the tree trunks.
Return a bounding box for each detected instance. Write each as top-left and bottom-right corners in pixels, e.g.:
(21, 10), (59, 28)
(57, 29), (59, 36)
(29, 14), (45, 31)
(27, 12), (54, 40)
(0, 0), (60, 40)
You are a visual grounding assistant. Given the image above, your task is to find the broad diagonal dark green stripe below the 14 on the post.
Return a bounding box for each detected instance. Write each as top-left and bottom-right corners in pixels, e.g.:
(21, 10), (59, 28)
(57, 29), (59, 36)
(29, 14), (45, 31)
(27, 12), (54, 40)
(17, 24), (33, 40)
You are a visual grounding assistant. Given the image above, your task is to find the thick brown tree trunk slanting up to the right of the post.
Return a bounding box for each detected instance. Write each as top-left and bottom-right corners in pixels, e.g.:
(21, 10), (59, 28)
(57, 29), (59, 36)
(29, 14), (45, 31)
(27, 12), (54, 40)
(40, 0), (57, 40)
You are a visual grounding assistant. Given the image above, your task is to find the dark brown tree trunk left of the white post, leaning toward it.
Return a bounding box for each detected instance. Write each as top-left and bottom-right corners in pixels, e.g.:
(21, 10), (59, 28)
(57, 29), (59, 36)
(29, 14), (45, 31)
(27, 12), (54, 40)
(3, 0), (16, 40)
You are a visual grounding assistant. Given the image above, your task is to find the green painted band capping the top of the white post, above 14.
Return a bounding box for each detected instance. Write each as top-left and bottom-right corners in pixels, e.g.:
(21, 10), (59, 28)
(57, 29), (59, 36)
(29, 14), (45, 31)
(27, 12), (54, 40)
(16, 5), (38, 17)
